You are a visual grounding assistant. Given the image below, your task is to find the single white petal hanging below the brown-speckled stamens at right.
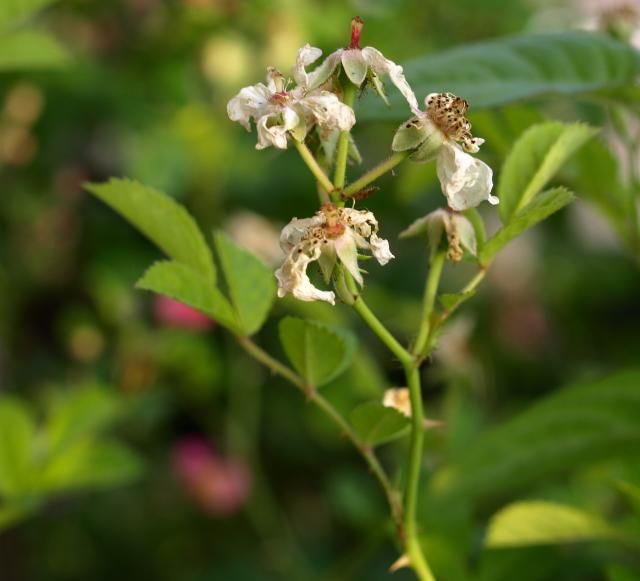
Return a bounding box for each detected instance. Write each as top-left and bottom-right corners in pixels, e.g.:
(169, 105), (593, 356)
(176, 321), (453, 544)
(436, 141), (498, 211)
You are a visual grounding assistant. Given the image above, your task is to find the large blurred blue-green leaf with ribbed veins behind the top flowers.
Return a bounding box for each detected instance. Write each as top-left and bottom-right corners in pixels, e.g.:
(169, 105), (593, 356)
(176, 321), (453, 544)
(359, 31), (640, 122)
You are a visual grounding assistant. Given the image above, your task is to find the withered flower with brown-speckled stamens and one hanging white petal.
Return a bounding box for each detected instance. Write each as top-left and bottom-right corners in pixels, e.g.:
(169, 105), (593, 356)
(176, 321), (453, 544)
(392, 93), (499, 211)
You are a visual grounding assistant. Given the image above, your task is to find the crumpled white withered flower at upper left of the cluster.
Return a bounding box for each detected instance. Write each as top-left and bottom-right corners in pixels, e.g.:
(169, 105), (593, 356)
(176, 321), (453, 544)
(227, 65), (356, 149)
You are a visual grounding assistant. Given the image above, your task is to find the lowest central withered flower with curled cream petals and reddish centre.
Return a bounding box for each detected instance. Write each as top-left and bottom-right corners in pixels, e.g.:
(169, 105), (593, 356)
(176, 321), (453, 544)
(276, 204), (394, 305)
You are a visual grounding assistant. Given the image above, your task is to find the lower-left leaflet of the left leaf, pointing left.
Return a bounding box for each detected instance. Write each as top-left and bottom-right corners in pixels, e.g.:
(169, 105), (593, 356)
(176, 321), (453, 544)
(136, 261), (239, 330)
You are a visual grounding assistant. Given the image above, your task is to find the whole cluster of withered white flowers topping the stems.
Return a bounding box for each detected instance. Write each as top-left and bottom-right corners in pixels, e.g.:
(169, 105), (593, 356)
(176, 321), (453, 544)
(227, 18), (498, 304)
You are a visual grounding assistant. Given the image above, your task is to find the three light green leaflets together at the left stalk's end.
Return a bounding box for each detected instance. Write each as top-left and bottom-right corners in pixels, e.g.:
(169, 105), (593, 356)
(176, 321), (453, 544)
(86, 179), (276, 336)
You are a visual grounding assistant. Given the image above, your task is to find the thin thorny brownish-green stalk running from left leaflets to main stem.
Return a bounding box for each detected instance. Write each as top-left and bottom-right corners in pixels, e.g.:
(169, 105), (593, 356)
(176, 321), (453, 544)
(236, 336), (404, 534)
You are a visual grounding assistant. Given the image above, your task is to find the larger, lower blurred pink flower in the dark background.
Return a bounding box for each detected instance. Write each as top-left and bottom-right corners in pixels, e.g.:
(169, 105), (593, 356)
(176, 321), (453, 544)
(173, 437), (252, 516)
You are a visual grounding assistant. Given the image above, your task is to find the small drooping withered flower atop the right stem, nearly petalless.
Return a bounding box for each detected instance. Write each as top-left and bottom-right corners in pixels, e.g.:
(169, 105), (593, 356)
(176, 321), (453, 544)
(400, 209), (477, 262)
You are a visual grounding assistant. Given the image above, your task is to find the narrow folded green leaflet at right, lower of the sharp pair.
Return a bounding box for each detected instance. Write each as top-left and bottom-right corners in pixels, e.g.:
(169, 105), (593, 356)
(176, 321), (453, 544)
(479, 188), (575, 264)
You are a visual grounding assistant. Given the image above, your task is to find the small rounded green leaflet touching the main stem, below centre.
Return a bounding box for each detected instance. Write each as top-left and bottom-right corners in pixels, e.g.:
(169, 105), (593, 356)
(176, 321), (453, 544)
(350, 401), (411, 446)
